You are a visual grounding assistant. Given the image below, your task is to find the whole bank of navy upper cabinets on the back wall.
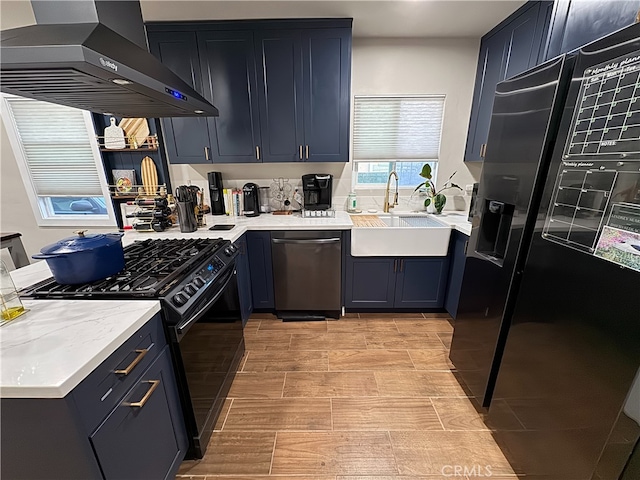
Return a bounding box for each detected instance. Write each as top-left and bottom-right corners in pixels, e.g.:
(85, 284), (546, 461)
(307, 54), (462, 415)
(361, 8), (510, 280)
(147, 19), (351, 163)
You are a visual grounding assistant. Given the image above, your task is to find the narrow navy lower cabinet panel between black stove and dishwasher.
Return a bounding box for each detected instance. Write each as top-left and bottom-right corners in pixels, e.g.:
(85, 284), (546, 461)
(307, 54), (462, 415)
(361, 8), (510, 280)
(246, 232), (275, 309)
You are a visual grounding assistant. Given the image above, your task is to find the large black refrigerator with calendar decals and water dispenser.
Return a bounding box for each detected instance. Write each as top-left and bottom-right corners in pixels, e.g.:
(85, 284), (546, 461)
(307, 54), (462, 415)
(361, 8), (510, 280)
(450, 25), (640, 480)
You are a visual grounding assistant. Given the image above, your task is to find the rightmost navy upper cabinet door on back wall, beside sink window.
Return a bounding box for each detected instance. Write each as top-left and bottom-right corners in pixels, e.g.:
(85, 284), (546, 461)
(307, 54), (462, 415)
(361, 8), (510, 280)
(303, 28), (351, 162)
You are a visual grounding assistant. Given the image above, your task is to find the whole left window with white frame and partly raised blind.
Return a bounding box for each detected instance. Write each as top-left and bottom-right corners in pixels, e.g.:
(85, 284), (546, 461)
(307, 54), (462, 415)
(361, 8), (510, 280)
(2, 95), (115, 226)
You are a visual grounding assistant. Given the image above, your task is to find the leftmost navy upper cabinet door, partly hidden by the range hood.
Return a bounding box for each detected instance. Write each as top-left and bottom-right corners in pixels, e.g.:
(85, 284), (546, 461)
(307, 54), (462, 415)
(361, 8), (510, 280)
(148, 32), (211, 163)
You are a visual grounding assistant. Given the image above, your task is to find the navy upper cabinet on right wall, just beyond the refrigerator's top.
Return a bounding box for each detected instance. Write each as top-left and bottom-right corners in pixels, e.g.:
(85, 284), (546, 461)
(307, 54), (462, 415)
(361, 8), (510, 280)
(464, 1), (553, 162)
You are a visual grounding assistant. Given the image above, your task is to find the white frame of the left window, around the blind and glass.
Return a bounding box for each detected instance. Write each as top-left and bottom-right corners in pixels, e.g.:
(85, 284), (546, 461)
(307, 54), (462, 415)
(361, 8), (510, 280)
(0, 93), (117, 228)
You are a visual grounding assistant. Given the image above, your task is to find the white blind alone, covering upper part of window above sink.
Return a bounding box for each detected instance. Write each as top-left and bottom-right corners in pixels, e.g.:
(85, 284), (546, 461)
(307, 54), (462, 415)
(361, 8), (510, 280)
(353, 95), (445, 162)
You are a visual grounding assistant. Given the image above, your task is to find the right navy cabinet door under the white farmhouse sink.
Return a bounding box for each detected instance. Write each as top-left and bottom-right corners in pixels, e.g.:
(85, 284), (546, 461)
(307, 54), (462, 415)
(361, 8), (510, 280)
(394, 257), (448, 308)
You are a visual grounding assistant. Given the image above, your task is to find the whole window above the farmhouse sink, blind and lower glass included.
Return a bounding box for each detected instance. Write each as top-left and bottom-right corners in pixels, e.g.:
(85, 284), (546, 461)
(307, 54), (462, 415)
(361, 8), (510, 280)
(353, 95), (445, 186)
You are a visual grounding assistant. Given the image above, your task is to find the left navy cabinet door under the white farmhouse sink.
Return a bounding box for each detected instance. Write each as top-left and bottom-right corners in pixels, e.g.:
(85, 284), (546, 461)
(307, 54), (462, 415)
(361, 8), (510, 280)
(345, 256), (396, 308)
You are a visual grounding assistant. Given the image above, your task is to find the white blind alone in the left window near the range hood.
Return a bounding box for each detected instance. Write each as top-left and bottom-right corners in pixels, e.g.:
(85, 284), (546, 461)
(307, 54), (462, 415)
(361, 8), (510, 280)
(7, 97), (103, 196)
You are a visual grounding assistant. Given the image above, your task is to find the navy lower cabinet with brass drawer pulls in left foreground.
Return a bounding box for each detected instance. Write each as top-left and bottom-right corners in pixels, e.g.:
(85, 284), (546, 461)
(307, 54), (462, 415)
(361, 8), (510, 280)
(0, 314), (188, 480)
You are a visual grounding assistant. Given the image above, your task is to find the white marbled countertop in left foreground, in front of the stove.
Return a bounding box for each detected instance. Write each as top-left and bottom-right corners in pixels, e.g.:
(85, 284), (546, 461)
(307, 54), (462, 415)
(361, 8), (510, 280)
(0, 300), (160, 398)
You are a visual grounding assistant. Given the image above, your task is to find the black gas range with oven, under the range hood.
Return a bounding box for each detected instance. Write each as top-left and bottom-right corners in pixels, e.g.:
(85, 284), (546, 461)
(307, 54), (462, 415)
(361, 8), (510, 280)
(23, 238), (244, 458)
